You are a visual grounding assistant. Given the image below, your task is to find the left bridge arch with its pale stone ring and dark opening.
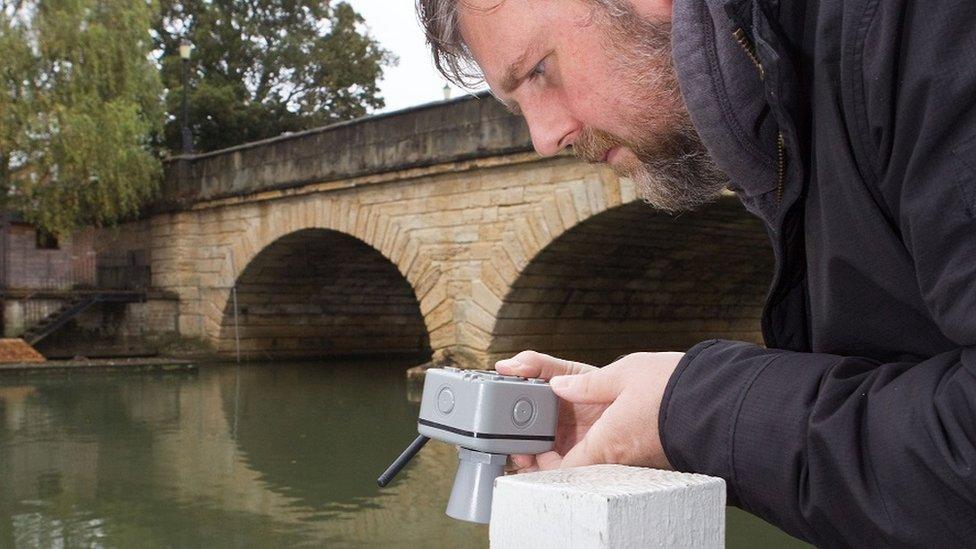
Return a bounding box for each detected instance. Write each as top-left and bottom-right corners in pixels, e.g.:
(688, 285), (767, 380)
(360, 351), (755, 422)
(201, 197), (449, 359)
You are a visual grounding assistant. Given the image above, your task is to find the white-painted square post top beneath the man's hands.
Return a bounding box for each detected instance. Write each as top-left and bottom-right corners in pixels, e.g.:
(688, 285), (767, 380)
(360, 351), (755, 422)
(489, 465), (725, 549)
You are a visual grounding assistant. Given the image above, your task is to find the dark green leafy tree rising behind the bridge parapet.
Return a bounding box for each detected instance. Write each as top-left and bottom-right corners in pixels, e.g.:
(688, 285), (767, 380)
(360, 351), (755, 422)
(155, 0), (396, 151)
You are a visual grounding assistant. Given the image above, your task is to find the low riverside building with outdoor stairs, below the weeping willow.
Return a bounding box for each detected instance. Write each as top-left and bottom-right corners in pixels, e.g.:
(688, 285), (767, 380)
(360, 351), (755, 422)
(0, 213), (168, 357)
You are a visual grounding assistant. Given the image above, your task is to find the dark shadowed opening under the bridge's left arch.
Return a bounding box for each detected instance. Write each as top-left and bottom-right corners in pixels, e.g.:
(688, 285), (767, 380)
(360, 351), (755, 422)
(218, 229), (431, 360)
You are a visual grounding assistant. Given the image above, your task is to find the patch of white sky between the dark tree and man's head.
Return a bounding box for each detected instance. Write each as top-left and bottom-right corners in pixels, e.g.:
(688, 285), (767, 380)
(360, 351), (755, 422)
(346, 0), (492, 112)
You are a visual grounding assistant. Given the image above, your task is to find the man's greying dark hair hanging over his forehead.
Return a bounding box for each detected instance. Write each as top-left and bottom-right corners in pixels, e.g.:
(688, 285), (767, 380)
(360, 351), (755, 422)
(417, 0), (633, 87)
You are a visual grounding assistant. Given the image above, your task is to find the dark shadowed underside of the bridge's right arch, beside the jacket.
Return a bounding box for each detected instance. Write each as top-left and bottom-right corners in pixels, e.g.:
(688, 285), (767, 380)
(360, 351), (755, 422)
(489, 198), (773, 364)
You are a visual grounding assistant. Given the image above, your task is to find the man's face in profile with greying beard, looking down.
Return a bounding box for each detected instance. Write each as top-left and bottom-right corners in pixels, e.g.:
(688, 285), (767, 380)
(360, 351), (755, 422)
(459, 0), (725, 211)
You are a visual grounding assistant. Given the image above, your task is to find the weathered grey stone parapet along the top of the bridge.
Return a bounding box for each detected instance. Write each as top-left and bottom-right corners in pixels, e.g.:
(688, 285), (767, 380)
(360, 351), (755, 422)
(156, 94), (532, 210)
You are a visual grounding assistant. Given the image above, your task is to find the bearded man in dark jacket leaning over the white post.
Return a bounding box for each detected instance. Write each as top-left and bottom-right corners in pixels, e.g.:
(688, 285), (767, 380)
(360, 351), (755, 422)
(418, 0), (976, 547)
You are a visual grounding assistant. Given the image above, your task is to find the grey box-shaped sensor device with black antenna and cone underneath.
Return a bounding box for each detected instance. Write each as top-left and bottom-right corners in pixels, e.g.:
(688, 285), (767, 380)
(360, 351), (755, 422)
(376, 368), (557, 523)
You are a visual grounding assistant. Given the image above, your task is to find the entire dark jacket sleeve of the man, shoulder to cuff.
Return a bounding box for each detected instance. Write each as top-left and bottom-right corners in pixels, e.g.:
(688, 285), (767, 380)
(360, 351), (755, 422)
(660, 0), (976, 547)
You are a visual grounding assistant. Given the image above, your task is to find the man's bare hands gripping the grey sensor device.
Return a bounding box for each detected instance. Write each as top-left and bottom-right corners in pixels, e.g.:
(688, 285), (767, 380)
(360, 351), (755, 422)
(495, 351), (684, 473)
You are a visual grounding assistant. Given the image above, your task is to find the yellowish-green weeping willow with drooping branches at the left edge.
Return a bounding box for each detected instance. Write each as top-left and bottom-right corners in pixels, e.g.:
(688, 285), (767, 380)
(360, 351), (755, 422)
(0, 0), (163, 235)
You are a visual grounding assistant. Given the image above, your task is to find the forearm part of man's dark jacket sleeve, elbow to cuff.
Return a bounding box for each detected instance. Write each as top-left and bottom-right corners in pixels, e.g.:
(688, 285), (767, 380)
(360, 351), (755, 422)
(660, 341), (976, 547)
